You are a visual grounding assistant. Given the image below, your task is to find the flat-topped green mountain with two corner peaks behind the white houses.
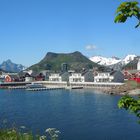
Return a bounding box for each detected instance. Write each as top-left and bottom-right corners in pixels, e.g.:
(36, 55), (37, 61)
(28, 51), (99, 71)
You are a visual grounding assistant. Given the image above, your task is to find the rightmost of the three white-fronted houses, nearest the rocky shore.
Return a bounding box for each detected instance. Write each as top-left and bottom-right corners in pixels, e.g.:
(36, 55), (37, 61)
(94, 72), (114, 82)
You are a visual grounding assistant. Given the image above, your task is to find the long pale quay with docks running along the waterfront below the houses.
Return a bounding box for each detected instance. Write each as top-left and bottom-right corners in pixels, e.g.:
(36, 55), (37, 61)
(0, 81), (125, 91)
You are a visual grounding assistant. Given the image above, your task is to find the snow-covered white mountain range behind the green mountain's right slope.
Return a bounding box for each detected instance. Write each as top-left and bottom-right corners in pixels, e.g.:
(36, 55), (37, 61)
(89, 54), (137, 66)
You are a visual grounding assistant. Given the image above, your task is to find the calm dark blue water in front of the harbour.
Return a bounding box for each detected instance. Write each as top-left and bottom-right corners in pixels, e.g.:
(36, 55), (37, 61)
(0, 90), (140, 140)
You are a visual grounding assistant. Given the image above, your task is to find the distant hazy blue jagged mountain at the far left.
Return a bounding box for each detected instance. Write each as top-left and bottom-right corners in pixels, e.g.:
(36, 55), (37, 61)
(0, 59), (25, 72)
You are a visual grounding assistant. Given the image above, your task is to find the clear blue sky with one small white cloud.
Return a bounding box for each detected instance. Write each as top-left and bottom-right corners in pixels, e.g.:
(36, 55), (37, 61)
(0, 0), (140, 66)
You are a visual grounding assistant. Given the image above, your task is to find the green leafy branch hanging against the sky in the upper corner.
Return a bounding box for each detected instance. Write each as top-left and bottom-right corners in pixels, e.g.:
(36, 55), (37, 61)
(114, 1), (140, 28)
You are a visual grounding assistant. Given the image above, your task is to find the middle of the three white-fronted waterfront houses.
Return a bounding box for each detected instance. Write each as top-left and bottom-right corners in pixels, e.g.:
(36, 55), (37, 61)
(69, 73), (85, 82)
